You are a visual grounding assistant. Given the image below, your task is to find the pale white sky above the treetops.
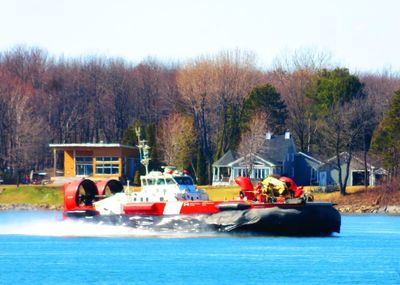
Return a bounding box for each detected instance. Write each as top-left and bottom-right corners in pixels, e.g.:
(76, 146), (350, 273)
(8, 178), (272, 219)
(0, 0), (400, 72)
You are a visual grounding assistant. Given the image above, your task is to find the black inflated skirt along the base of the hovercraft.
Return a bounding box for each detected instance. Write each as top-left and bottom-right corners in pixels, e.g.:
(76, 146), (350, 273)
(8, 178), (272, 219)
(64, 202), (341, 236)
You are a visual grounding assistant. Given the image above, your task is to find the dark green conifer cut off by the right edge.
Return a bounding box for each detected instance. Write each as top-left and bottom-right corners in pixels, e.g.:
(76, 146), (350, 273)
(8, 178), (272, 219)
(372, 90), (400, 177)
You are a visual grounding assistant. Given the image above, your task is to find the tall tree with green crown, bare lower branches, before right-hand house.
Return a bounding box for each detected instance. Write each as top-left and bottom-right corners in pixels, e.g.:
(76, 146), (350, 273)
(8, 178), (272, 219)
(309, 68), (371, 195)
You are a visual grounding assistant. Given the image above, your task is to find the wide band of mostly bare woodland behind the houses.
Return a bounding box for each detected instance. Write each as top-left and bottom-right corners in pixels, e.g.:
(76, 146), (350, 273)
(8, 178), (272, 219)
(0, 47), (400, 193)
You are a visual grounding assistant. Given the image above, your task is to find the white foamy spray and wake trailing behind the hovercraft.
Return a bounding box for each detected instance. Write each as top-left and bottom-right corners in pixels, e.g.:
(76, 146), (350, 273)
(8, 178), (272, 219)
(0, 211), (220, 238)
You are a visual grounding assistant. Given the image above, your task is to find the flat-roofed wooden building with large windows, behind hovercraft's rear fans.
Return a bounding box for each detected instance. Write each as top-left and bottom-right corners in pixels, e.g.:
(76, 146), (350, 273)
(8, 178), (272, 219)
(49, 143), (139, 181)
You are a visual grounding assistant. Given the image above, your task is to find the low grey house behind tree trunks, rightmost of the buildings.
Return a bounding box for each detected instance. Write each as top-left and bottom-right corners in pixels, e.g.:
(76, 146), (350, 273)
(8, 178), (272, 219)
(318, 152), (387, 187)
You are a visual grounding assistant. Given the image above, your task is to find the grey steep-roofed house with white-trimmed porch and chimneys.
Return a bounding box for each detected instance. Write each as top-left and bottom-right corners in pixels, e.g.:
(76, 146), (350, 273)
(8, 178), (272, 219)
(212, 132), (296, 185)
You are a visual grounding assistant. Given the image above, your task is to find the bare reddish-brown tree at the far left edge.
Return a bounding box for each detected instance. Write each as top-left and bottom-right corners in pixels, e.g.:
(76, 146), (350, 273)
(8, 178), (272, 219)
(0, 70), (48, 175)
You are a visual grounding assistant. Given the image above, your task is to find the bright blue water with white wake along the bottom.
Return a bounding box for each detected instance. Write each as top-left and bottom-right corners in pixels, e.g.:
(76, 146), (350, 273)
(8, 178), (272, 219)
(0, 212), (400, 284)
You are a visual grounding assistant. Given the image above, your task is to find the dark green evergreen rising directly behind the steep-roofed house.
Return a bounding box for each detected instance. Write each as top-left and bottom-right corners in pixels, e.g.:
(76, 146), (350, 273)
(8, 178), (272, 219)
(242, 84), (287, 134)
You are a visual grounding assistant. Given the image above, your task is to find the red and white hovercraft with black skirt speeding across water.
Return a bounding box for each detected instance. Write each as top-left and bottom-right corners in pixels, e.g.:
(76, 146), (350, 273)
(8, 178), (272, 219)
(63, 170), (341, 236)
